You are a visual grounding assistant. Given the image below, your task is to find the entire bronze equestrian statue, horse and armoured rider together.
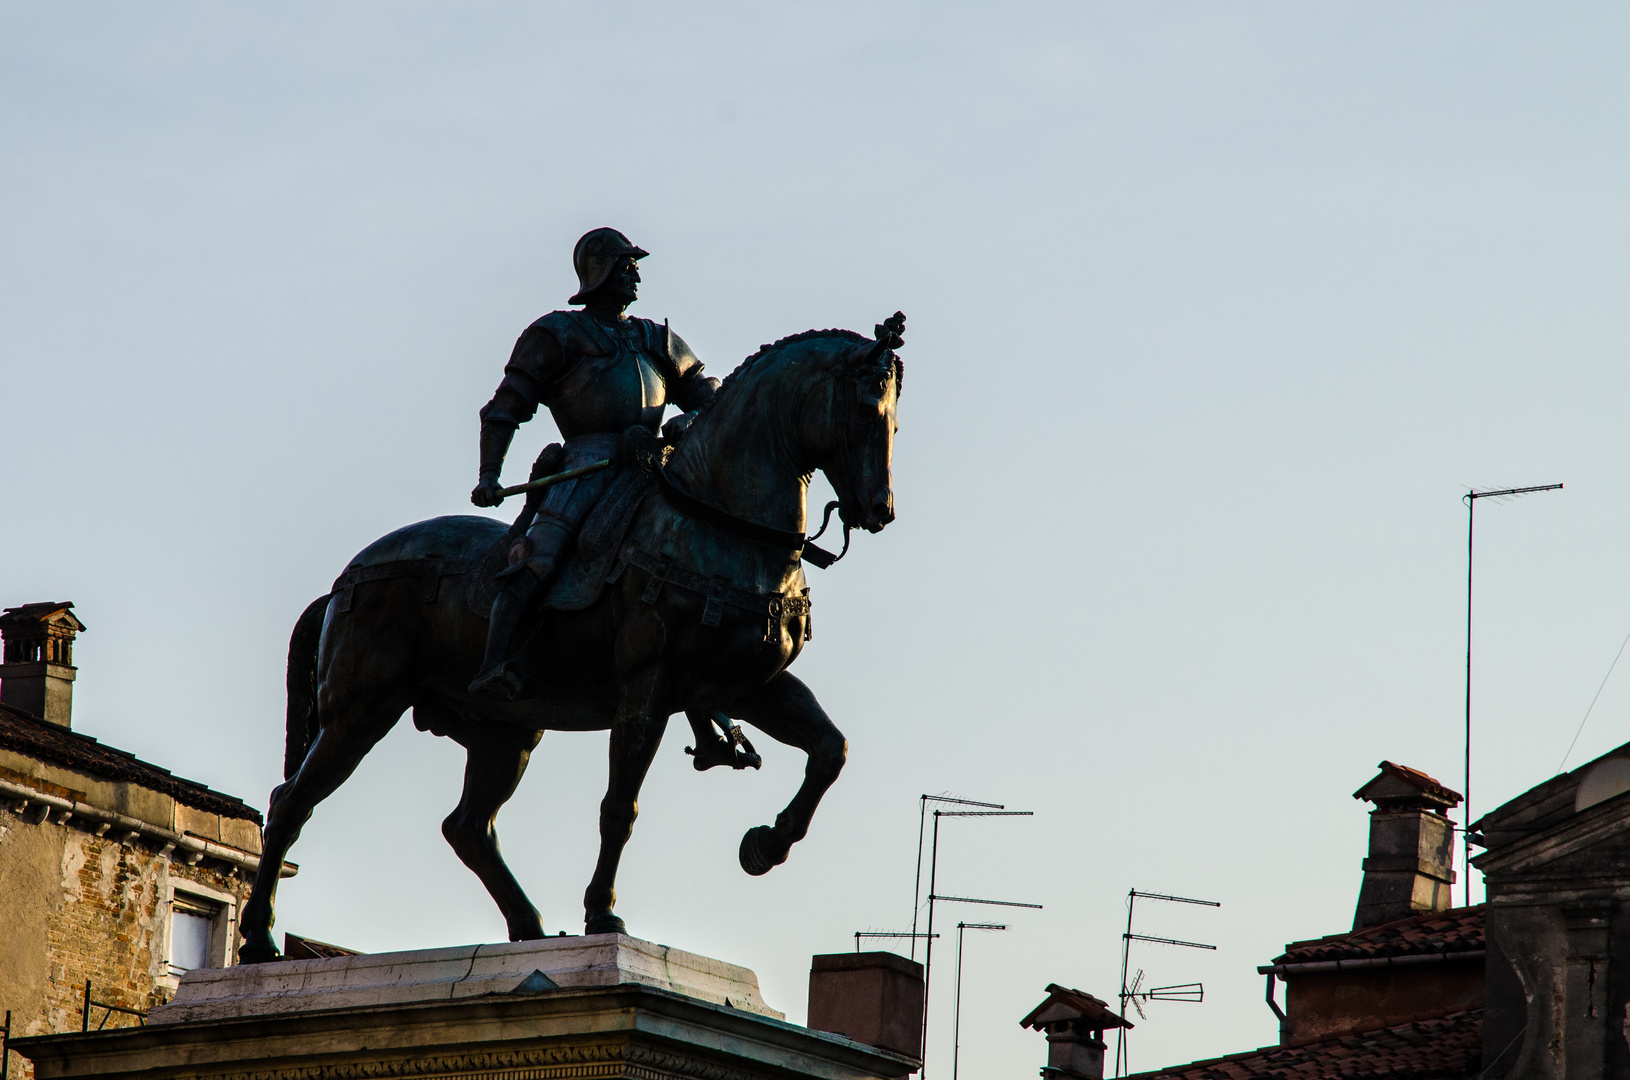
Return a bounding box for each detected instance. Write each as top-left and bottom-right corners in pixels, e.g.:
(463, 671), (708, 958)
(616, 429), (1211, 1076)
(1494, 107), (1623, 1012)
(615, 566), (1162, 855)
(240, 230), (905, 963)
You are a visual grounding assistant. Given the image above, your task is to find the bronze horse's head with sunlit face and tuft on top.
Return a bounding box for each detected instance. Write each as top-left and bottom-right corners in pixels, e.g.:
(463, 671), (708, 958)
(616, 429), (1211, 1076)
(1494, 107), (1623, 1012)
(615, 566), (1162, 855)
(820, 311), (906, 533)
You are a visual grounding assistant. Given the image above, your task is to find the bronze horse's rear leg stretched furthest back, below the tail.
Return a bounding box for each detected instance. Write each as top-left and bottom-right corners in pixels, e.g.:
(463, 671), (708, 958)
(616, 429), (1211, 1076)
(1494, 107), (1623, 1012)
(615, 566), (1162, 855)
(238, 700), (408, 964)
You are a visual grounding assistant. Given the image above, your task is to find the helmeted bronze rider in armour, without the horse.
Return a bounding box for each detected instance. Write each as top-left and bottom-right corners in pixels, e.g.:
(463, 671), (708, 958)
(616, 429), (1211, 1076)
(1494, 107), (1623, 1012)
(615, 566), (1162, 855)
(469, 228), (719, 700)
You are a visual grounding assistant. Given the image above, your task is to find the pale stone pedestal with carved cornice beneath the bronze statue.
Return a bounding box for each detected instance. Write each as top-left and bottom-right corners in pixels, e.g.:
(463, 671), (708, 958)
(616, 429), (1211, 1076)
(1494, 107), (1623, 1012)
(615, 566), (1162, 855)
(13, 935), (918, 1080)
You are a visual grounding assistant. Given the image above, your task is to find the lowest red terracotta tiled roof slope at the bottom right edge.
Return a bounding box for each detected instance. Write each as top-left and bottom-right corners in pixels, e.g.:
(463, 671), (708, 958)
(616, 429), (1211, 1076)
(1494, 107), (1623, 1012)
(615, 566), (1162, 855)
(1128, 1008), (1483, 1080)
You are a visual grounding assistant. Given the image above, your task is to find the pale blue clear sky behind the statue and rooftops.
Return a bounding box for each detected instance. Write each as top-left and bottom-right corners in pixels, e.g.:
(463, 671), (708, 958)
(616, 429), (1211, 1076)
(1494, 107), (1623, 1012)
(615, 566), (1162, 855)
(0, 3), (1630, 1077)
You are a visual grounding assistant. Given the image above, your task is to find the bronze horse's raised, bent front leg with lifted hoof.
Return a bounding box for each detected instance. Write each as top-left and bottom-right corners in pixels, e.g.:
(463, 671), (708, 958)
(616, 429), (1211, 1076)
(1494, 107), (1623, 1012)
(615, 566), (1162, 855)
(730, 671), (849, 875)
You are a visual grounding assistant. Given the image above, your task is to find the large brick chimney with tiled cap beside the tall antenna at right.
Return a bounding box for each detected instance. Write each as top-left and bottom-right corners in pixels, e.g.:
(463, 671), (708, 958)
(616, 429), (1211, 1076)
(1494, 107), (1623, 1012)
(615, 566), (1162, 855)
(1353, 761), (1460, 930)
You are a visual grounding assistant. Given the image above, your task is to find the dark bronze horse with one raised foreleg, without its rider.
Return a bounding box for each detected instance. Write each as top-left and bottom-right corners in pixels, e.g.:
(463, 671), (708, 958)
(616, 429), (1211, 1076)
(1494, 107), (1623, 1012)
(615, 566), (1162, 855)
(240, 313), (905, 963)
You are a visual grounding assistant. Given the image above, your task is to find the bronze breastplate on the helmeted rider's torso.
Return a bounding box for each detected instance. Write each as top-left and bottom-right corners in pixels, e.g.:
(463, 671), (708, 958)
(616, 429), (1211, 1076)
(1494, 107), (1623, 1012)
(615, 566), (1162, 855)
(548, 319), (667, 438)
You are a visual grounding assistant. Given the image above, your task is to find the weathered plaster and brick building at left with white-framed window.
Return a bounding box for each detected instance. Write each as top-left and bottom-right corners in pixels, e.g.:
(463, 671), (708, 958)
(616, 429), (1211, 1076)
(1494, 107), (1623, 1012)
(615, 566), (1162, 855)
(0, 606), (278, 1080)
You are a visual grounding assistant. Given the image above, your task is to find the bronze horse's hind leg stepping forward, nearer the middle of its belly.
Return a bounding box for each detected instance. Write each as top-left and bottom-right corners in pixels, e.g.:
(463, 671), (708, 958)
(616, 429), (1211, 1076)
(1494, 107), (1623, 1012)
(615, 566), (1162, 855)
(442, 723), (543, 942)
